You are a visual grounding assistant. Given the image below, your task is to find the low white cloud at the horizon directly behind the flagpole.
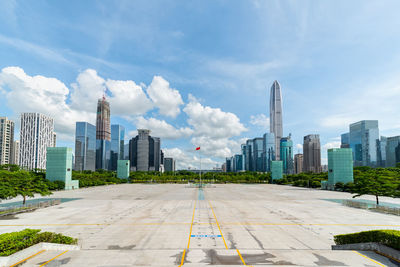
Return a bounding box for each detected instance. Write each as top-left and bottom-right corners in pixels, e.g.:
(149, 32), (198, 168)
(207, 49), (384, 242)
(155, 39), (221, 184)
(162, 148), (220, 170)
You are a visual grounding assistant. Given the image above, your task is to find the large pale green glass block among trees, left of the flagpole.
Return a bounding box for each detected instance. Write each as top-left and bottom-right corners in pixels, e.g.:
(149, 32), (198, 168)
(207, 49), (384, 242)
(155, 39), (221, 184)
(46, 147), (79, 190)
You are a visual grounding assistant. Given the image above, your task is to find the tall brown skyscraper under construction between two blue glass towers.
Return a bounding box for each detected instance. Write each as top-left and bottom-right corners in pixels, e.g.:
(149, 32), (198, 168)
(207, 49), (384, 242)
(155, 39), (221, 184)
(96, 96), (111, 170)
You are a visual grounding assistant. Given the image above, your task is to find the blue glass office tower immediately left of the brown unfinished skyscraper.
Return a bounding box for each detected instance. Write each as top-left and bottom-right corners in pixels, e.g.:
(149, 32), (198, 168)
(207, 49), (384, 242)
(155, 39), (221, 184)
(74, 122), (96, 171)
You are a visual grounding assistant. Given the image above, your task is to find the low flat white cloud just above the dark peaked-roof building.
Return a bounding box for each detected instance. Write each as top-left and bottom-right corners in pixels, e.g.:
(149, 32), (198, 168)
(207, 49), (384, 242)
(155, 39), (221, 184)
(131, 116), (193, 139)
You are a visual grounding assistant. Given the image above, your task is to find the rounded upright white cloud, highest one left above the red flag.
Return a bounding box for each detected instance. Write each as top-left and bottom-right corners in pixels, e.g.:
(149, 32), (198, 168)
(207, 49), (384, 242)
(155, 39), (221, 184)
(147, 76), (183, 118)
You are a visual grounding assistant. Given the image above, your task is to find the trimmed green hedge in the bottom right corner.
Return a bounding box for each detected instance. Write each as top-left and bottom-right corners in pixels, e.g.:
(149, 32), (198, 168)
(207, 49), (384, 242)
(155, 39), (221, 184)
(334, 230), (400, 250)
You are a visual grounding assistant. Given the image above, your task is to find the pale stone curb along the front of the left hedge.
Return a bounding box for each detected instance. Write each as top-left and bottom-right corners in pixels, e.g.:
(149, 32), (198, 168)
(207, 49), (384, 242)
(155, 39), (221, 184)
(0, 242), (81, 267)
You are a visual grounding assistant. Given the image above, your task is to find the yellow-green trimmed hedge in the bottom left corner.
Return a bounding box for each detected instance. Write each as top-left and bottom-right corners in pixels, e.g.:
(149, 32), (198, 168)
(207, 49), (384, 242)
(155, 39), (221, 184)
(0, 229), (78, 256)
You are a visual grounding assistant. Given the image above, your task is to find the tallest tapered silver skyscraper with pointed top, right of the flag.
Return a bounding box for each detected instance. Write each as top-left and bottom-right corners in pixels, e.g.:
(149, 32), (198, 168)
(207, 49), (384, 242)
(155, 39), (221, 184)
(269, 81), (283, 160)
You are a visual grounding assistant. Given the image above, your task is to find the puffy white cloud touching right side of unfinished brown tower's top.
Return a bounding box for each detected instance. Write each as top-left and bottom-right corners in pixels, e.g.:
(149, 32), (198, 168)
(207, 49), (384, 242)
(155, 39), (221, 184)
(106, 80), (153, 116)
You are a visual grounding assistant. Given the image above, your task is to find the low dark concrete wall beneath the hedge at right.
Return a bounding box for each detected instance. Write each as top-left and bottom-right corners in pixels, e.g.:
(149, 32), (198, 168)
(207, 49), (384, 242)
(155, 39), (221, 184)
(332, 242), (400, 262)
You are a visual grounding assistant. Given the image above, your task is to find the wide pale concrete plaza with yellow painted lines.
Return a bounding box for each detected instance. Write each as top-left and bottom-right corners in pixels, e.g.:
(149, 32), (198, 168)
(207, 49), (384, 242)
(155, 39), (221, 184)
(0, 184), (400, 267)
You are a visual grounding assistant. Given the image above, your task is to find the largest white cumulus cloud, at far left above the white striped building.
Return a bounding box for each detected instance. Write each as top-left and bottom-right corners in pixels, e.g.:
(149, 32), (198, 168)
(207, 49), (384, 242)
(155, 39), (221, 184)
(0, 67), (95, 137)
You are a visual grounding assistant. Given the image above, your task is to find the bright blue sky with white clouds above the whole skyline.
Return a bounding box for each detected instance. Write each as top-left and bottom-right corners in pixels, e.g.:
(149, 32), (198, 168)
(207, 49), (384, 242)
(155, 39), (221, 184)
(0, 0), (400, 169)
